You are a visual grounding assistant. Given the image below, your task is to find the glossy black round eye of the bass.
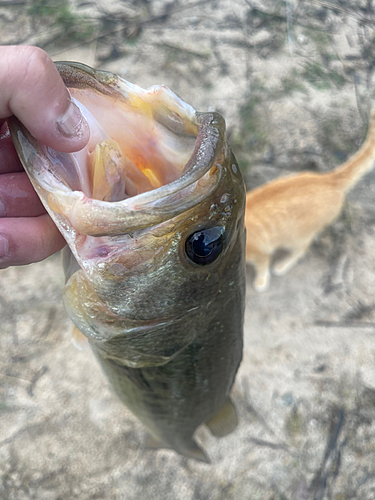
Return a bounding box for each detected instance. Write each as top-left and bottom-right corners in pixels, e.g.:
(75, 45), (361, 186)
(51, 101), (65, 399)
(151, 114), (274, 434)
(185, 226), (224, 266)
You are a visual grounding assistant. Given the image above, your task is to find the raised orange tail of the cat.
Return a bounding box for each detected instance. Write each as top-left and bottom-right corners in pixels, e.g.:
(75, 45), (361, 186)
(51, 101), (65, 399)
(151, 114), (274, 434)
(332, 107), (375, 192)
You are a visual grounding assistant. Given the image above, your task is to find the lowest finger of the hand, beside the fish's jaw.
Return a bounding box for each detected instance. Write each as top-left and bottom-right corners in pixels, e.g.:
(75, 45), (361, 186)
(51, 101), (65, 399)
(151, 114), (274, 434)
(0, 214), (65, 269)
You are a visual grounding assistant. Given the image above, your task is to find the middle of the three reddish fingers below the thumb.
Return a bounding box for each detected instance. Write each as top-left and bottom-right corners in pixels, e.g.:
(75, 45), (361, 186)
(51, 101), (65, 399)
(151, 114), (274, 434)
(0, 172), (45, 217)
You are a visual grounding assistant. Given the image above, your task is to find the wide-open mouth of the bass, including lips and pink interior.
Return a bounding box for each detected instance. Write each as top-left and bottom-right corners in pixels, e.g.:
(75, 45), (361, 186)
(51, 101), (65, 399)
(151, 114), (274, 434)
(9, 62), (225, 248)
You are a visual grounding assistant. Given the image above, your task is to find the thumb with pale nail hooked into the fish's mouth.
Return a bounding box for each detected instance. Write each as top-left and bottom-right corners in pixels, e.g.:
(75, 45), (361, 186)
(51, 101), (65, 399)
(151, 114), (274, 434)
(0, 46), (89, 152)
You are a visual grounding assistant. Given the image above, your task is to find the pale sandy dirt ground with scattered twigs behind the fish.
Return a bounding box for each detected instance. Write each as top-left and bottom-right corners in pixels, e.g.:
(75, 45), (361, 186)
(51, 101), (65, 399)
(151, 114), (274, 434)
(0, 0), (375, 500)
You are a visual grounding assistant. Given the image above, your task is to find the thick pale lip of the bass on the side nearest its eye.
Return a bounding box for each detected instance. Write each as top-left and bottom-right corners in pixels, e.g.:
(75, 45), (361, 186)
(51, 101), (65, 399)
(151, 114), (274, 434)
(43, 113), (225, 236)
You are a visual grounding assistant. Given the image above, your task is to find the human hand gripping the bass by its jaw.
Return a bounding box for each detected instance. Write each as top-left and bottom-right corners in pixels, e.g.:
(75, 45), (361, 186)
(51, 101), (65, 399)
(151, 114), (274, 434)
(0, 46), (89, 269)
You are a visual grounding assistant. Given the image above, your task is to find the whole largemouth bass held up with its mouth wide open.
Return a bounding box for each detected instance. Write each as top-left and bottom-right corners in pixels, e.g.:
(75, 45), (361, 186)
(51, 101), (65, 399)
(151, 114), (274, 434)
(9, 63), (245, 461)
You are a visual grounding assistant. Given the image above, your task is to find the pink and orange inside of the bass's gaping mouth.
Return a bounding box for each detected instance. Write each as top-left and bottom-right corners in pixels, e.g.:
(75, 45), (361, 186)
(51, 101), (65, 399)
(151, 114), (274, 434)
(54, 63), (199, 205)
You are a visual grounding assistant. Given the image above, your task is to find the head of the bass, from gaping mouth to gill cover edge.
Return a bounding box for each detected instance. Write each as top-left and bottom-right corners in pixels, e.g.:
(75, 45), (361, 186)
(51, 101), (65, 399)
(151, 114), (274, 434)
(9, 63), (245, 366)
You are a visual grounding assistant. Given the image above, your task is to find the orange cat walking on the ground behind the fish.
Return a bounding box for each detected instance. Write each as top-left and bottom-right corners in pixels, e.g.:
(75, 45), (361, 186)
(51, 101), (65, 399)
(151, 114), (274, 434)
(245, 110), (375, 292)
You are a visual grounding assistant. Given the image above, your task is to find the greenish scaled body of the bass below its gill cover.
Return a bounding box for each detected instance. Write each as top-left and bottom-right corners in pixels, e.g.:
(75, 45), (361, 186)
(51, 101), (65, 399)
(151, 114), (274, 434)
(93, 287), (243, 460)
